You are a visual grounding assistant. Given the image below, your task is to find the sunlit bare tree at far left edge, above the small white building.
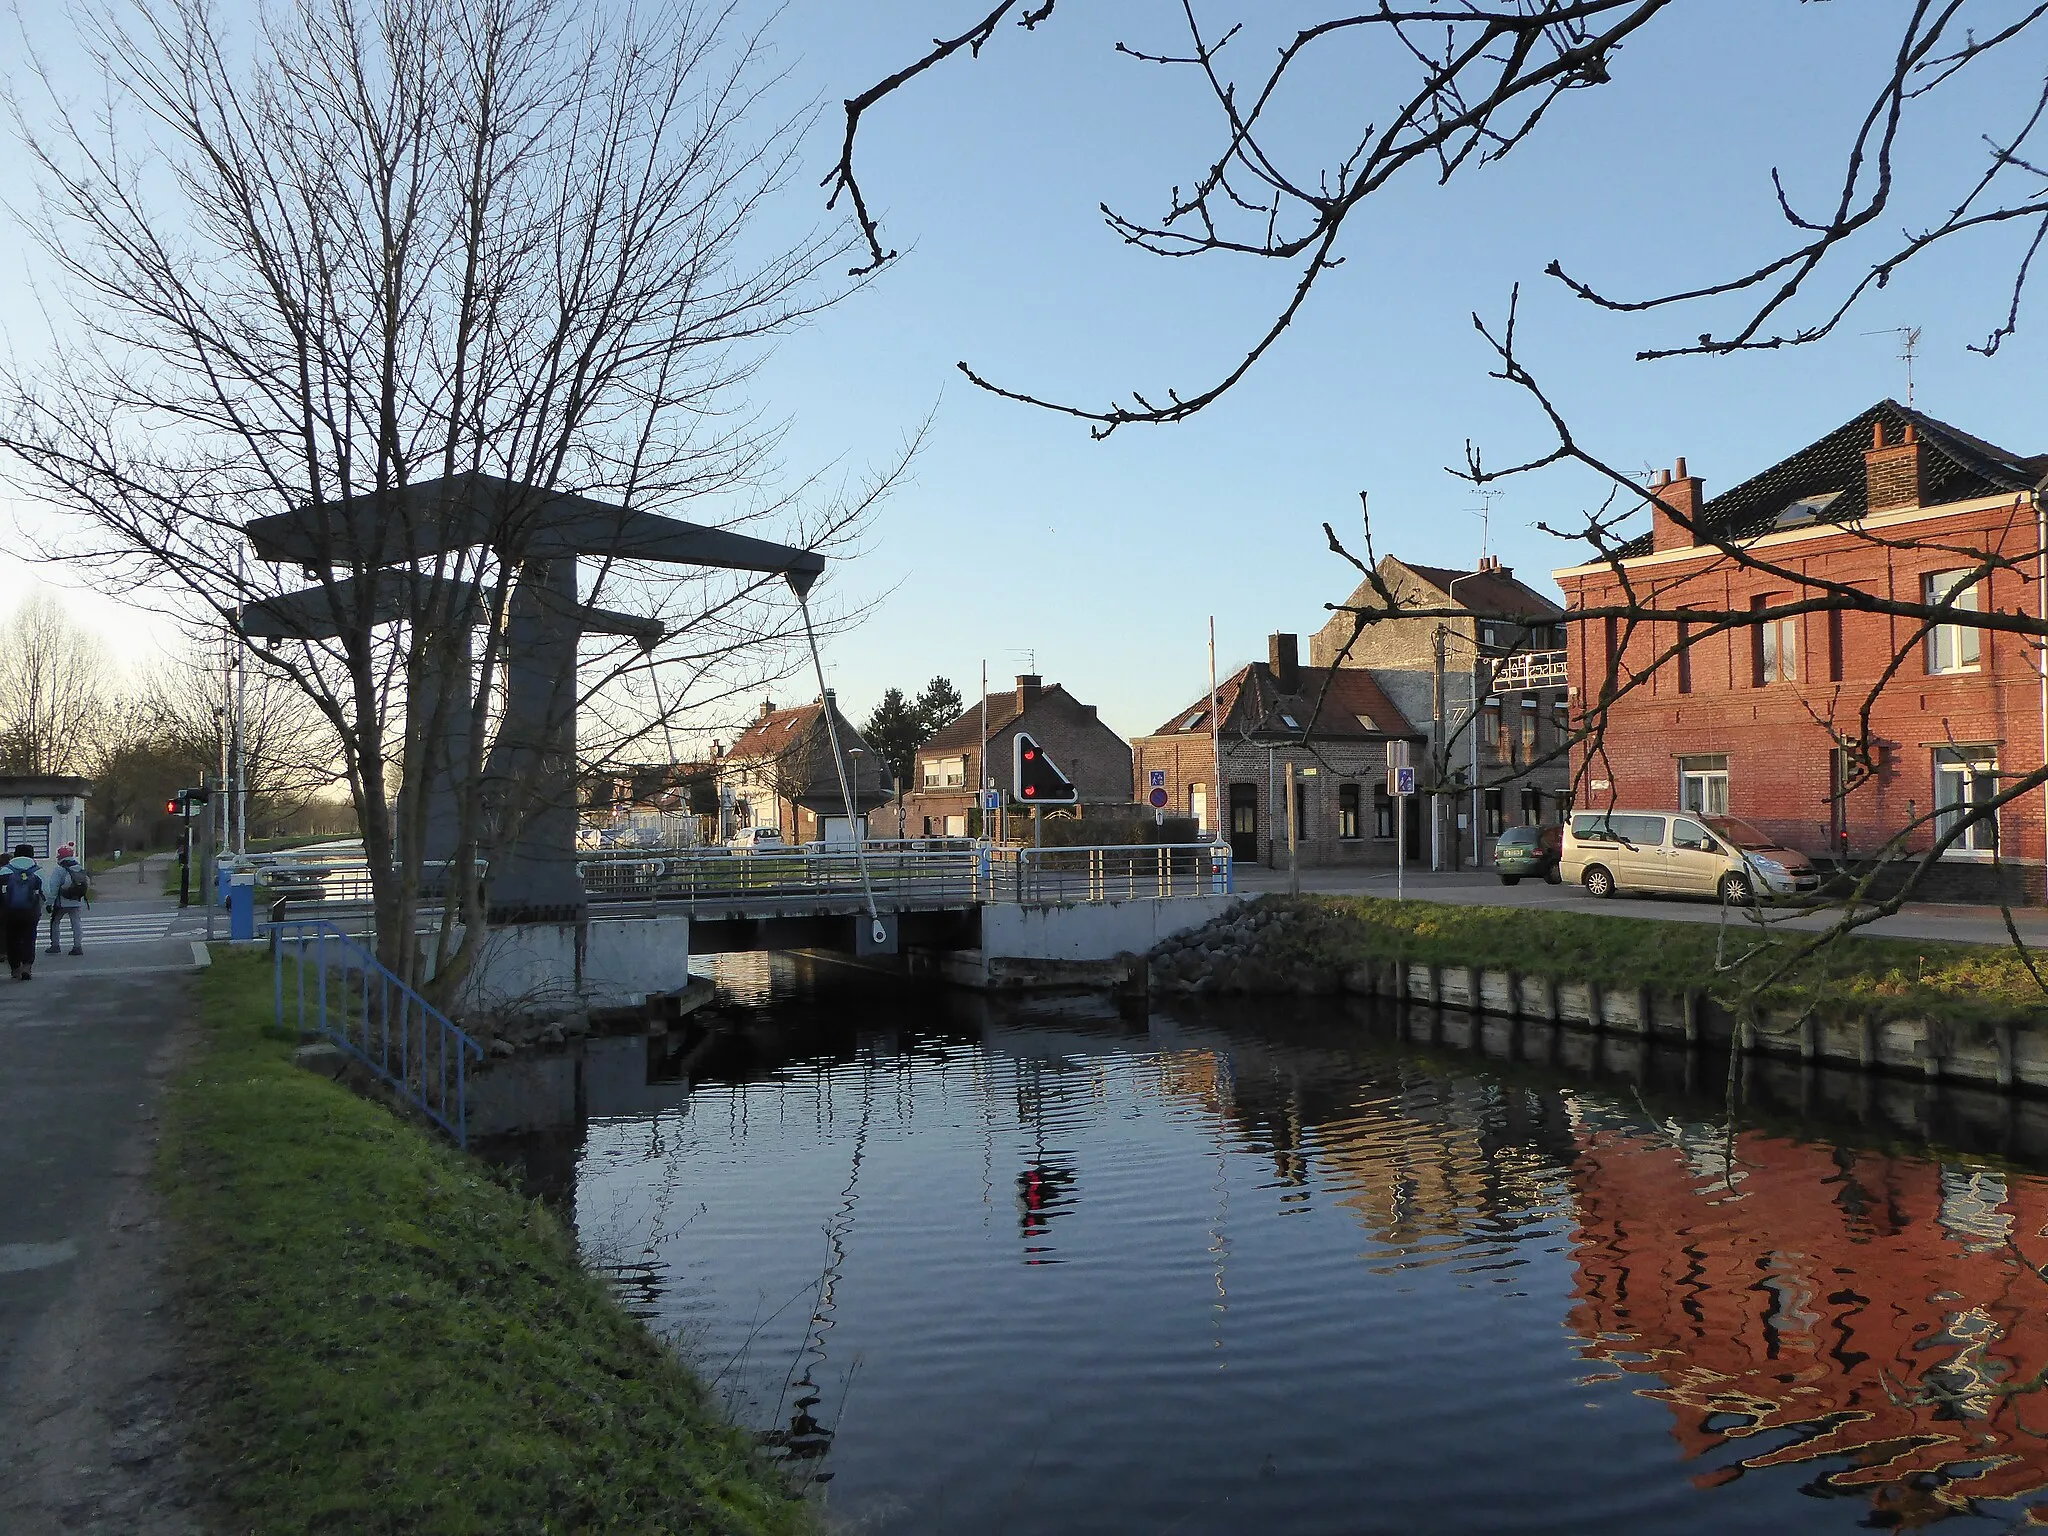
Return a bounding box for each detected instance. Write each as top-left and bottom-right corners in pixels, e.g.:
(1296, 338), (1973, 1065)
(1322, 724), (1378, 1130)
(0, 590), (113, 774)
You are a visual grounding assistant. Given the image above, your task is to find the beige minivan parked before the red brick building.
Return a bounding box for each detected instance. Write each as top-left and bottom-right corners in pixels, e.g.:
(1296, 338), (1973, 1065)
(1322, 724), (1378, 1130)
(1559, 811), (1821, 905)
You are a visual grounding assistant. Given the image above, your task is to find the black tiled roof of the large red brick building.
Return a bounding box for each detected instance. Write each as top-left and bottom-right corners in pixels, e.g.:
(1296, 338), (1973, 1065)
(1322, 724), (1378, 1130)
(1620, 399), (2048, 559)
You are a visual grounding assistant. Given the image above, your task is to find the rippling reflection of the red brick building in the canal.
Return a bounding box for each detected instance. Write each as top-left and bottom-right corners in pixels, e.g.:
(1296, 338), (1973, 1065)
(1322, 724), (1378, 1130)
(1571, 1128), (2048, 1528)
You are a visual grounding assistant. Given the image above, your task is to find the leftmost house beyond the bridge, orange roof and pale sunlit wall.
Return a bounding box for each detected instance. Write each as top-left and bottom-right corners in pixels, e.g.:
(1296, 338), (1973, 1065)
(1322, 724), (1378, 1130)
(717, 692), (895, 842)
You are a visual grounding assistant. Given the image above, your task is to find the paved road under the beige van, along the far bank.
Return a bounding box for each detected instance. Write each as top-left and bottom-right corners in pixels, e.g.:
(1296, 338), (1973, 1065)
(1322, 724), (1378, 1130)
(1235, 864), (2048, 946)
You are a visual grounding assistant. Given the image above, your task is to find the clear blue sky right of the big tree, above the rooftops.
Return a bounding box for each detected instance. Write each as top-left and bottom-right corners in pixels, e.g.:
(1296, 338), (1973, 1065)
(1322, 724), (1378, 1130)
(0, 0), (2048, 735)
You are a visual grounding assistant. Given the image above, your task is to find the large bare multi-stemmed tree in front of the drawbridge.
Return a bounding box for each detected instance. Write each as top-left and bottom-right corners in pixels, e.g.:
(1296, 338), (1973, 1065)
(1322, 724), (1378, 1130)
(0, 0), (901, 995)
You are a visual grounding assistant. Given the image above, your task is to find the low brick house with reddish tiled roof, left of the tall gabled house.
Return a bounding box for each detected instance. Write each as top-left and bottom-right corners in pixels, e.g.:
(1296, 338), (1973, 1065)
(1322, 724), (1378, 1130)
(1130, 635), (1425, 868)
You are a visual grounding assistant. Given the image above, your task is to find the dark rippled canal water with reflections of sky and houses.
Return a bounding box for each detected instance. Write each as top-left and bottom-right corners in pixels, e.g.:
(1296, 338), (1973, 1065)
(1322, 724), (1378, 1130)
(563, 956), (2048, 1536)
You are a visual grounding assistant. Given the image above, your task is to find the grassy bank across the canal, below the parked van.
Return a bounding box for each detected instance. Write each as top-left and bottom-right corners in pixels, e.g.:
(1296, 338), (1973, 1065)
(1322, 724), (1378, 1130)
(1262, 897), (2048, 1024)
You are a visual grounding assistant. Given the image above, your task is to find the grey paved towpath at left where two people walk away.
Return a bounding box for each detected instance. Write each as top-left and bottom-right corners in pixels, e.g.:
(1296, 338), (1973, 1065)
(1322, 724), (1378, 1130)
(0, 860), (195, 1536)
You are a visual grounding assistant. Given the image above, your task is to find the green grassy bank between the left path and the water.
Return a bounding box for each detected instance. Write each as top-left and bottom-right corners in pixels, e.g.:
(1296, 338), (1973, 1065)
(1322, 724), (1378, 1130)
(160, 956), (811, 1536)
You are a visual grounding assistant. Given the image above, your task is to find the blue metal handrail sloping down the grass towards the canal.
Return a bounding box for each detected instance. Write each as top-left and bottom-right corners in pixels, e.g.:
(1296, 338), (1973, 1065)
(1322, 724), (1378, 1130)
(270, 918), (483, 1147)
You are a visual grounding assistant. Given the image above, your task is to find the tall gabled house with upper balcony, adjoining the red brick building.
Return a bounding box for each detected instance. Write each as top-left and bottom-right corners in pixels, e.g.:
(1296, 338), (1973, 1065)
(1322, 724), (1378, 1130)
(1309, 555), (1571, 868)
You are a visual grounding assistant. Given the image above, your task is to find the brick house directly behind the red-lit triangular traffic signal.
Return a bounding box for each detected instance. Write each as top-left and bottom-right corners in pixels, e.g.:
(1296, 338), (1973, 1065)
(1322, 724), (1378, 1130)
(903, 672), (1130, 838)
